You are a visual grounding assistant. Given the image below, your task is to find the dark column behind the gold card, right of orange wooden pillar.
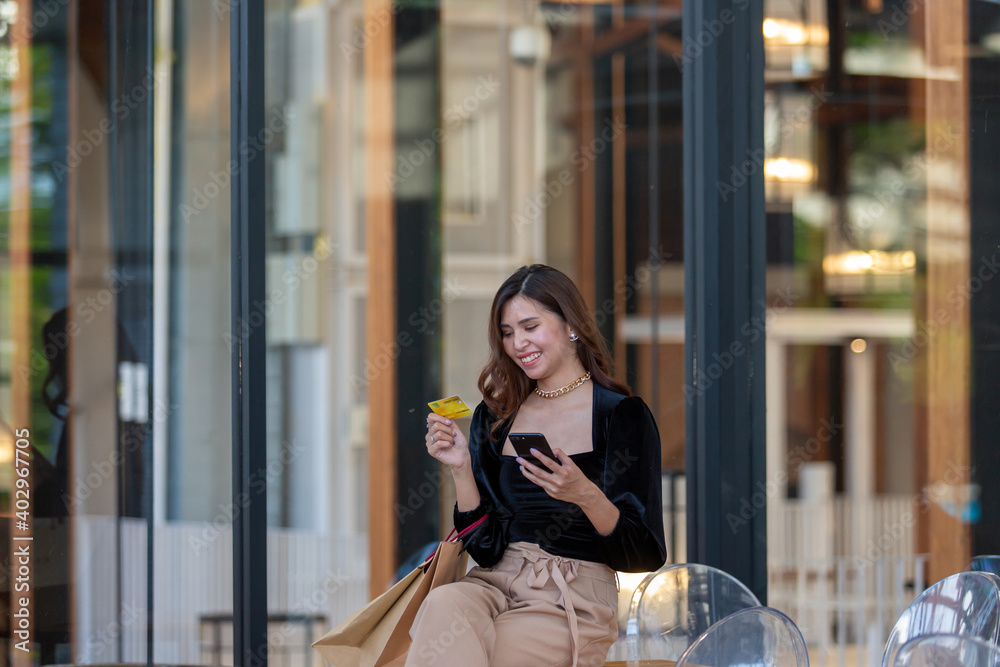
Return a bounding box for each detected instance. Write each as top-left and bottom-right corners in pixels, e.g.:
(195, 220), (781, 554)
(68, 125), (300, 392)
(392, 2), (444, 567)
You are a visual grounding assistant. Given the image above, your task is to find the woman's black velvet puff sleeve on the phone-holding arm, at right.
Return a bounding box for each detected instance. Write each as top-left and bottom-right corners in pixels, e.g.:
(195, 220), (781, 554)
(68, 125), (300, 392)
(595, 396), (667, 572)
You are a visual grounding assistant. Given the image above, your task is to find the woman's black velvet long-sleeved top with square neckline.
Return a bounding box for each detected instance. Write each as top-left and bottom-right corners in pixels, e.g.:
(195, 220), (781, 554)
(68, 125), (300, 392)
(455, 383), (667, 572)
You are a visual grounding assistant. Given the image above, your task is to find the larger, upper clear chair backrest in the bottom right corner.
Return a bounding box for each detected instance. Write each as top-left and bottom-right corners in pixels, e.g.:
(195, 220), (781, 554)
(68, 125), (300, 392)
(882, 572), (1000, 667)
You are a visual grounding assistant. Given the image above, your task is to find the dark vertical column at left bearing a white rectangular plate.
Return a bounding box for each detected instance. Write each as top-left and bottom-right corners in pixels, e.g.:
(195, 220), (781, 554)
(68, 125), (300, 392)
(105, 0), (158, 665)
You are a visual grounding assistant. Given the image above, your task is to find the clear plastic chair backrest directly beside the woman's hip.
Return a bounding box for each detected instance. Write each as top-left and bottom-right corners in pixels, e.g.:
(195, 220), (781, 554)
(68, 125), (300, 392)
(625, 563), (760, 660)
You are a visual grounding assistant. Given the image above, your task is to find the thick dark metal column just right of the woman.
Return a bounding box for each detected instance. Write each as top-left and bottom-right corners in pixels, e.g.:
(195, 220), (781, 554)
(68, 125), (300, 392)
(683, 0), (767, 601)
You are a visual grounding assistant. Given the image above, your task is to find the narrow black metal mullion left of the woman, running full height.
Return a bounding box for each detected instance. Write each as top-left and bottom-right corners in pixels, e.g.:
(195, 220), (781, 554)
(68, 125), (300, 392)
(229, 2), (267, 667)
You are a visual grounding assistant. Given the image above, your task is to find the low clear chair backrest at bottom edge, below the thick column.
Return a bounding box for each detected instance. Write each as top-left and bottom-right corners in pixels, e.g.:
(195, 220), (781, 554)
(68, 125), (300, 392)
(676, 607), (809, 667)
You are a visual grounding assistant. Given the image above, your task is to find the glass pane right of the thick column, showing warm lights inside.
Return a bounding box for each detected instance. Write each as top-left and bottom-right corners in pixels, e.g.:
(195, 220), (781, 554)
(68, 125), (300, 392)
(760, 0), (1000, 664)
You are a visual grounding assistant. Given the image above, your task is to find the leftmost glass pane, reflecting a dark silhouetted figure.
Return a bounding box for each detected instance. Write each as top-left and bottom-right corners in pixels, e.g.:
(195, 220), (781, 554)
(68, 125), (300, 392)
(0, 2), (234, 665)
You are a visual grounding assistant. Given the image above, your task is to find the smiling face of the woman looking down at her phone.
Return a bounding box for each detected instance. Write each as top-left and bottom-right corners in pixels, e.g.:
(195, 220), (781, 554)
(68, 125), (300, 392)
(500, 296), (576, 380)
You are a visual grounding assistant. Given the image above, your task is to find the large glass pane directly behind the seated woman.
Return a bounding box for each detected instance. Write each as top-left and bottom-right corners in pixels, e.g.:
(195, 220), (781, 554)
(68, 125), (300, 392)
(267, 0), (684, 661)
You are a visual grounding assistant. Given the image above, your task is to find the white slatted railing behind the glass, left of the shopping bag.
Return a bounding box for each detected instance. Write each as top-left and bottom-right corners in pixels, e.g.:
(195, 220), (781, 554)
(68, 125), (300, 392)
(71, 516), (368, 665)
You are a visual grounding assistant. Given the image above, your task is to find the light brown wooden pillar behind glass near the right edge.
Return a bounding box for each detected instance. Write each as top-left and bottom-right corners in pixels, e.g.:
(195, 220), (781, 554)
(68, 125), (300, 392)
(914, 0), (971, 582)
